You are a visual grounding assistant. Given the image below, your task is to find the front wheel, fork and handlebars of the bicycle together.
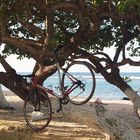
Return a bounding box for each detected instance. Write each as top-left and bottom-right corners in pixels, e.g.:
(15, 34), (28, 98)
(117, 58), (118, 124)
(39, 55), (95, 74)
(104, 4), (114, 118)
(22, 75), (52, 132)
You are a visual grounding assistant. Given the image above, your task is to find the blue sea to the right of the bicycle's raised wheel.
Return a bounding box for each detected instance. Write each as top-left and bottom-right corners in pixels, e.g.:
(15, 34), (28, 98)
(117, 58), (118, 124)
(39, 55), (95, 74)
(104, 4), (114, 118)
(94, 73), (140, 99)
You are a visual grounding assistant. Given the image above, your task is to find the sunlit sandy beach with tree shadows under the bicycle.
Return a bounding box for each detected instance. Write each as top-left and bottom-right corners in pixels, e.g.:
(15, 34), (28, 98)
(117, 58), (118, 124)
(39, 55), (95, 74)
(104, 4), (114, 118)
(0, 92), (140, 140)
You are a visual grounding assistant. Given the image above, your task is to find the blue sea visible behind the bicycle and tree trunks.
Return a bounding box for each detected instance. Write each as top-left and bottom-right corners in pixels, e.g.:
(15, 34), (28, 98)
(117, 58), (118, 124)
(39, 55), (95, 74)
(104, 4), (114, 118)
(2, 72), (140, 100)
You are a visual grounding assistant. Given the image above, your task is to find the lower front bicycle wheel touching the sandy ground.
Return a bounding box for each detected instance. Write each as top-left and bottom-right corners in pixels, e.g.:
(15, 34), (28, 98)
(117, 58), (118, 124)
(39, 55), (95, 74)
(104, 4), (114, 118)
(23, 88), (52, 132)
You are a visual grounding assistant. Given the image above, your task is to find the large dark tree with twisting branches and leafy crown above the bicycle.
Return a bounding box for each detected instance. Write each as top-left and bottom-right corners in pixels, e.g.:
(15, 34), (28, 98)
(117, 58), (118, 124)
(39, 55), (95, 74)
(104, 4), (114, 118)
(0, 0), (140, 138)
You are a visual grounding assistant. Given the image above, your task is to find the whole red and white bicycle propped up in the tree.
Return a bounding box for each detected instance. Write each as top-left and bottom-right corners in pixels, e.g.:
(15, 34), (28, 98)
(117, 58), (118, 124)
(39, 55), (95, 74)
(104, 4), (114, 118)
(23, 46), (96, 131)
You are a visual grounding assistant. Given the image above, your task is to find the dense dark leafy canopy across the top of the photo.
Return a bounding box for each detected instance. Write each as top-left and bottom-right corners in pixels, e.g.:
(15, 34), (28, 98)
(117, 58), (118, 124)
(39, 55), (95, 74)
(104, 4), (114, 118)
(0, 0), (140, 58)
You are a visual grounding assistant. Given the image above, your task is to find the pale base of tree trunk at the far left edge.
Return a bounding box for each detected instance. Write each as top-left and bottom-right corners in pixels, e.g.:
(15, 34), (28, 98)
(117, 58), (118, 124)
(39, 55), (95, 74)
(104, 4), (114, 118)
(0, 84), (13, 109)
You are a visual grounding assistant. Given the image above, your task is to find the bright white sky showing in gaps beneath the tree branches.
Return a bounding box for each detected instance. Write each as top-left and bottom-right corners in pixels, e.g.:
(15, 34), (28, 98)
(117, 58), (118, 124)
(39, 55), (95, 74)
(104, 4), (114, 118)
(0, 45), (140, 72)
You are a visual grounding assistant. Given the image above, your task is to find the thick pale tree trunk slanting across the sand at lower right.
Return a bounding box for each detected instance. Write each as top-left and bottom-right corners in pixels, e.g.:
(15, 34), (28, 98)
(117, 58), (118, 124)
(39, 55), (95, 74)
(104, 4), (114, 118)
(51, 97), (140, 140)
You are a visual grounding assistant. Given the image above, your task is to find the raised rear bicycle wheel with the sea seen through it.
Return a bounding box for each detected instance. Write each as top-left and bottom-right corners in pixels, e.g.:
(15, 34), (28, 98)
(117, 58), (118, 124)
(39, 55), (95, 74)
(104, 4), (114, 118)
(62, 61), (96, 105)
